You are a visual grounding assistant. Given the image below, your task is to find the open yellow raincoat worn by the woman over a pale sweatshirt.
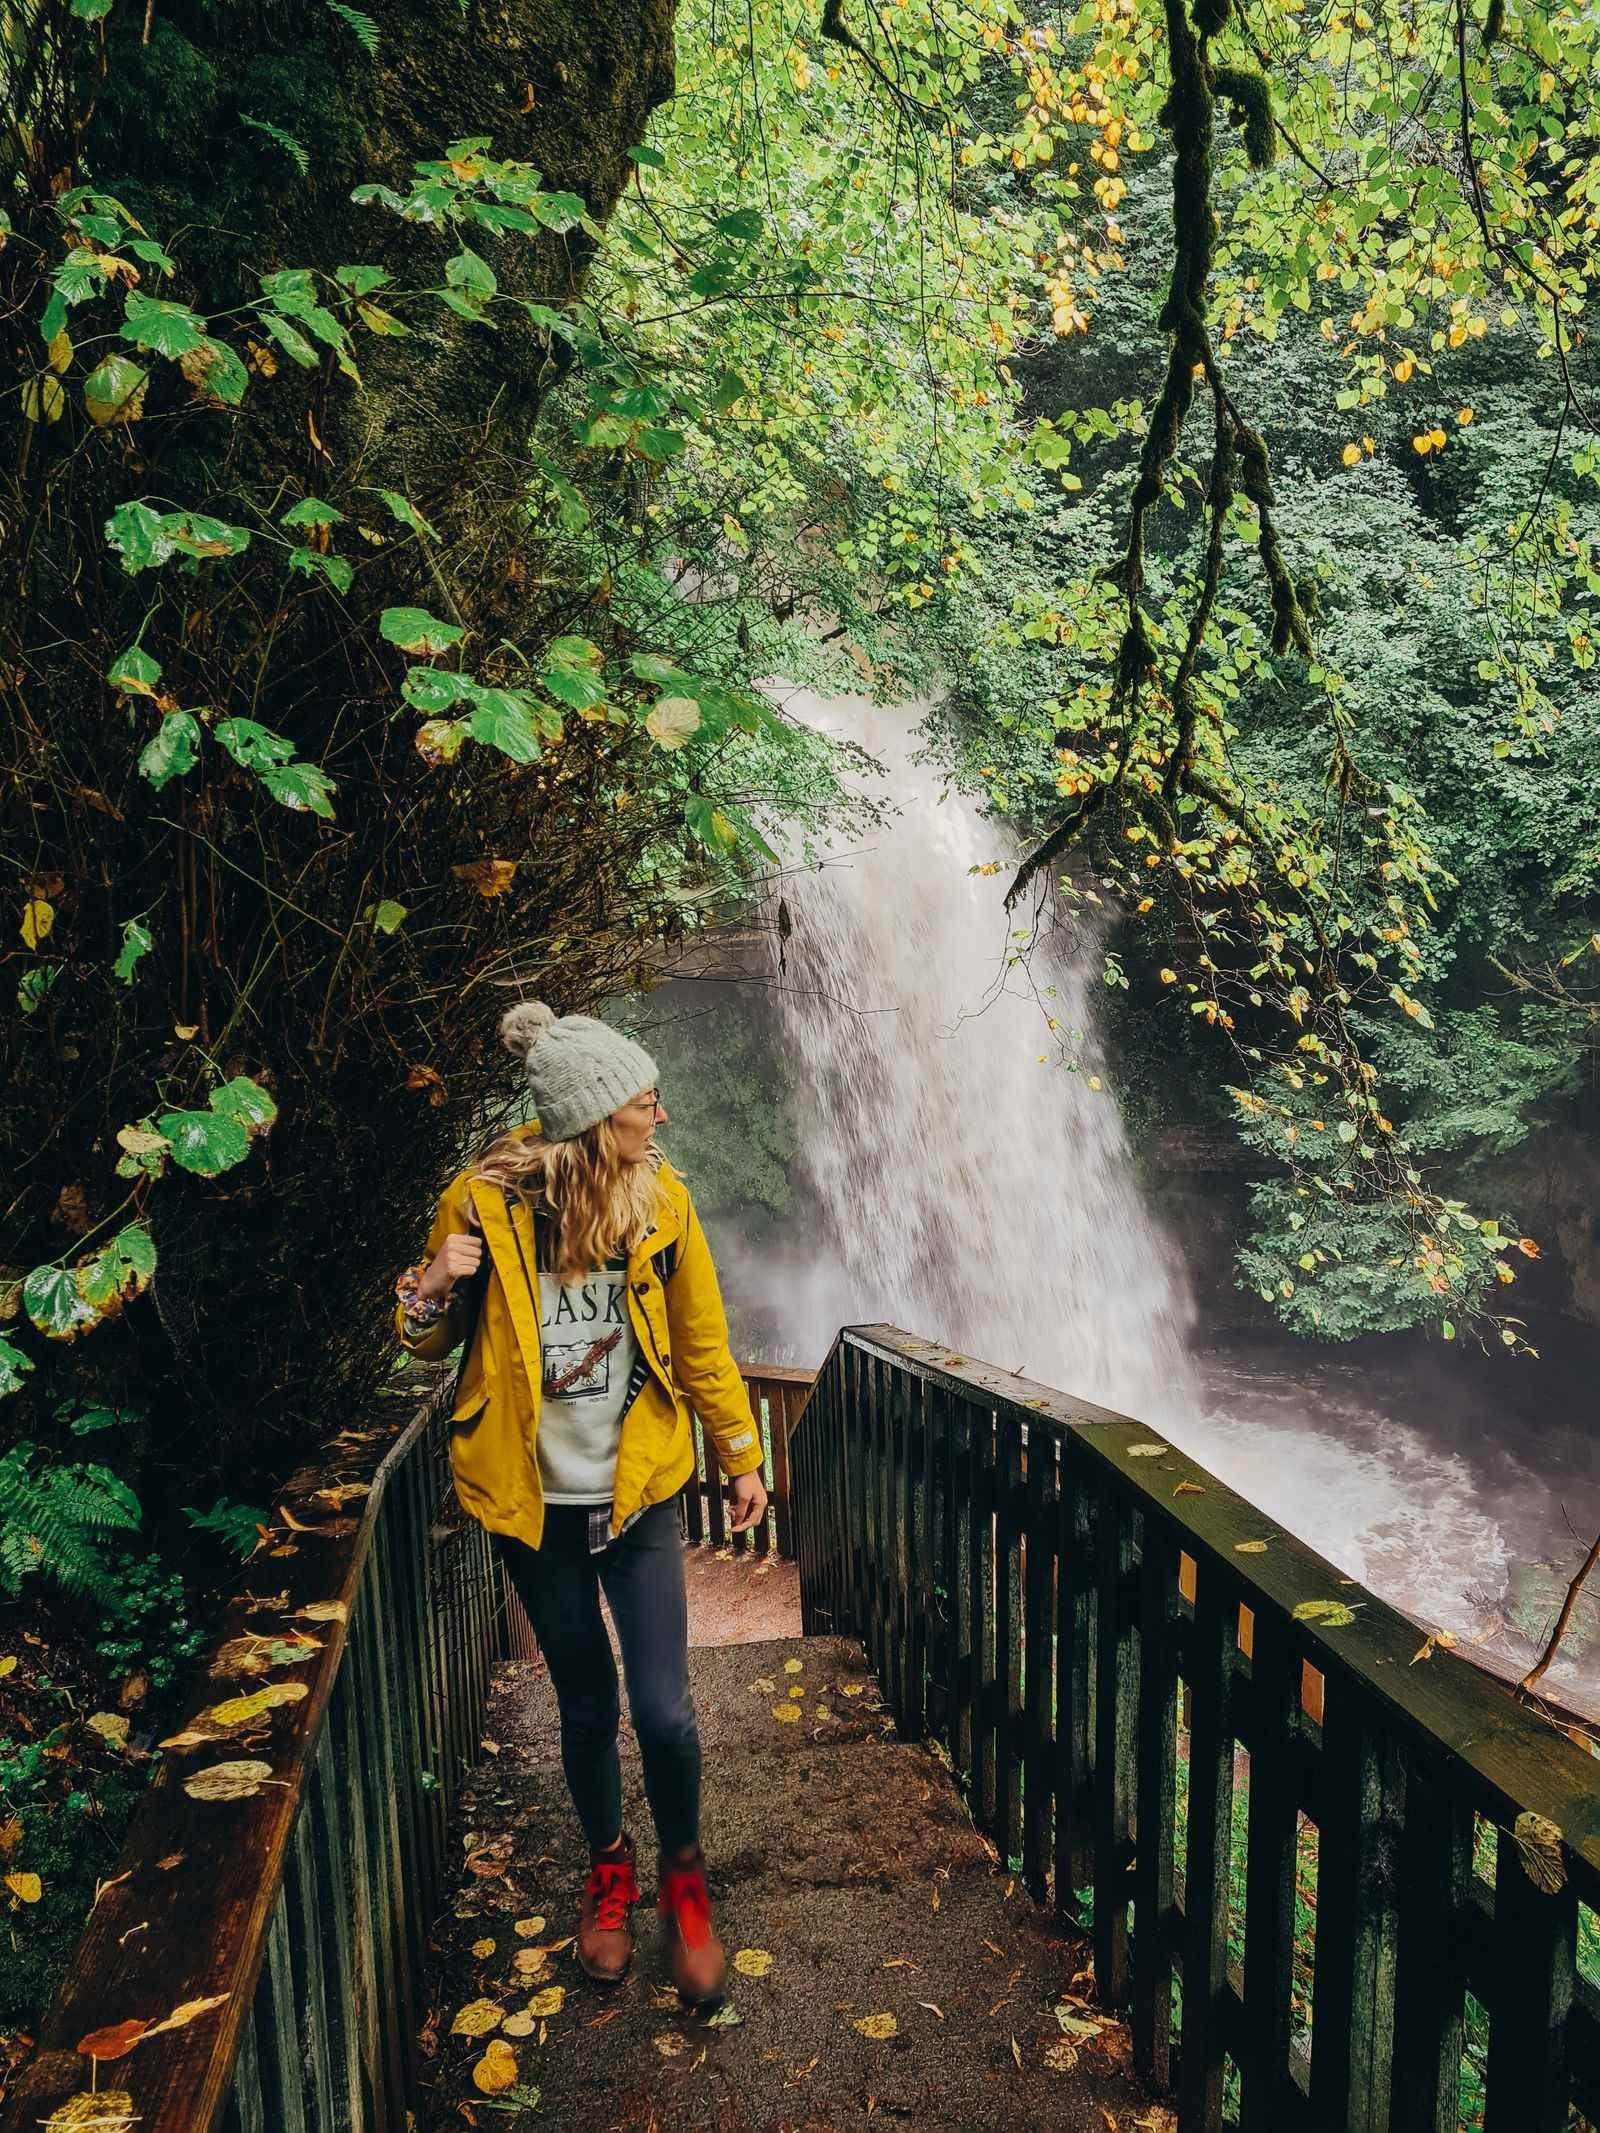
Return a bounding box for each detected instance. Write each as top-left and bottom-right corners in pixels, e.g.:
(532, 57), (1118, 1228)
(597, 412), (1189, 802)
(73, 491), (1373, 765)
(395, 1165), (762, 1549)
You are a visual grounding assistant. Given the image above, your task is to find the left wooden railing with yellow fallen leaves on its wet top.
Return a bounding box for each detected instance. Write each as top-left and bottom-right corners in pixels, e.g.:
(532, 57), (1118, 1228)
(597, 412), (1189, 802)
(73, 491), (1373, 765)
(2, 1365), (531, 2133)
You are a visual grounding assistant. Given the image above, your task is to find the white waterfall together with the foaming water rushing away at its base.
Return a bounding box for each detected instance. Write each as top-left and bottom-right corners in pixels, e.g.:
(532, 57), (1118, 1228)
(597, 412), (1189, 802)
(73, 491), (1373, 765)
(740, 687), (1544, 1634)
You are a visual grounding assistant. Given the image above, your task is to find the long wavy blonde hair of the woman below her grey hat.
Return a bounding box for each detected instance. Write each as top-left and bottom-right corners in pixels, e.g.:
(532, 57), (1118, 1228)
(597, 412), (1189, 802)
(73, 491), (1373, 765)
(471, 1118), (661, 1282)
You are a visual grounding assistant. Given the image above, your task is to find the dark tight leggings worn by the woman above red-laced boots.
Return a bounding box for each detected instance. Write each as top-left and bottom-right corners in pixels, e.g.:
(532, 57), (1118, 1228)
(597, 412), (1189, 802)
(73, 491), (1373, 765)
(495, 1497), (700, 1851)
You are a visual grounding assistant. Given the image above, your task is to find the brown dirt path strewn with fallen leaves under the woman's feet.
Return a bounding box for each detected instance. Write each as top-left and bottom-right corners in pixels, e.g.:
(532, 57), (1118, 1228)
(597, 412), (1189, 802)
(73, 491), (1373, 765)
(416, 1604), (1173, 2133)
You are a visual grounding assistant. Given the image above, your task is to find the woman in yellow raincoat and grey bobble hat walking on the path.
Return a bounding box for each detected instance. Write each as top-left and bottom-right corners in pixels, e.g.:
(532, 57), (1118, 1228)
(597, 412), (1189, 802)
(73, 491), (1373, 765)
(397, 1000), (766, 2003)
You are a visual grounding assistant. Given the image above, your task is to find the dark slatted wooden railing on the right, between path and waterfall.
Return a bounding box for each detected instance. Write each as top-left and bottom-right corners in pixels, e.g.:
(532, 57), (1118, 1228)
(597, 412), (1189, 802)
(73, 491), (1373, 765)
(789, 1327), (1600, 2133)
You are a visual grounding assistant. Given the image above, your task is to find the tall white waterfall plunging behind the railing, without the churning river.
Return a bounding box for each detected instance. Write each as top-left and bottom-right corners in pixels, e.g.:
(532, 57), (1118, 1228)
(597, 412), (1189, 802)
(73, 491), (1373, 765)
(768, 689), (1190, 1425)
